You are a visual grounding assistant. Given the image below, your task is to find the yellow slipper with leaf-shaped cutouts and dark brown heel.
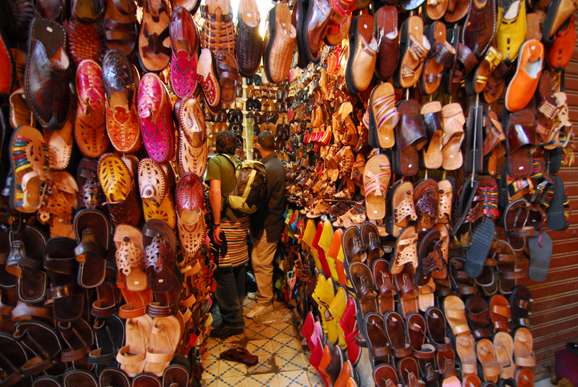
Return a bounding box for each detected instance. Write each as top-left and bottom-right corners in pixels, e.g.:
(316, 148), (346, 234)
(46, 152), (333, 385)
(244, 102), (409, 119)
(97, 153), (141, 226)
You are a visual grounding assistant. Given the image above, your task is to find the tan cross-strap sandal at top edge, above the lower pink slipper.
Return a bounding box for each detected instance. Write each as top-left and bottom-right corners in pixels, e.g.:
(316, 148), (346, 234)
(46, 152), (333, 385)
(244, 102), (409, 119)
(138, 0), (171, 71)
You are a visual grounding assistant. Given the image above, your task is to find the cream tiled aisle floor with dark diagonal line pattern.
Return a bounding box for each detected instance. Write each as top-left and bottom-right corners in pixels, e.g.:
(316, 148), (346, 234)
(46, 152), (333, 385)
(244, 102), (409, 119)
(201, 298), (323, 387)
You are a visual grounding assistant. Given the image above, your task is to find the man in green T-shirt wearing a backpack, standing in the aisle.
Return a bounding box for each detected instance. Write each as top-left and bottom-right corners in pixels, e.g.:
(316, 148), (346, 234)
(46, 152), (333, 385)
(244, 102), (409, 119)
(205, 130), (249, 339)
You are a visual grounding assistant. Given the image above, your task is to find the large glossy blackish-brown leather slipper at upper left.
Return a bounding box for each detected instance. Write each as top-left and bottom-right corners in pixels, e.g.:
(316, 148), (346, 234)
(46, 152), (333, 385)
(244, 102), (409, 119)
(24, 18), (72, 129)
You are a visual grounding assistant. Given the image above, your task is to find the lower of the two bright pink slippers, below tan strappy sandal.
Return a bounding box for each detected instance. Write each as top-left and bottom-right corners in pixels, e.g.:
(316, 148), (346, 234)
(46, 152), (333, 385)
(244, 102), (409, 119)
(137, 73), (175, 164)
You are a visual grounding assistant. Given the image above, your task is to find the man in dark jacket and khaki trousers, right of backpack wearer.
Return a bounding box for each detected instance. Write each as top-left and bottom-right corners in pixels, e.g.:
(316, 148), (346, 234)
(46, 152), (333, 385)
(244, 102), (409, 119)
(247, 132), (285, 318)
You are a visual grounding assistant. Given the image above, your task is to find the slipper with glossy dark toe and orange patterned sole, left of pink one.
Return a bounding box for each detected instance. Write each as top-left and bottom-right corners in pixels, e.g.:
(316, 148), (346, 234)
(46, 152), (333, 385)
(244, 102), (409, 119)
(102, 50), (142, 153)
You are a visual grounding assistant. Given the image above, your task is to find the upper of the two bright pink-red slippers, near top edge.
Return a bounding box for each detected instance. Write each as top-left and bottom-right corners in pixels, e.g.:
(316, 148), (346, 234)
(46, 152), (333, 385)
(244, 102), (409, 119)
(169, 7), (199, 98)
